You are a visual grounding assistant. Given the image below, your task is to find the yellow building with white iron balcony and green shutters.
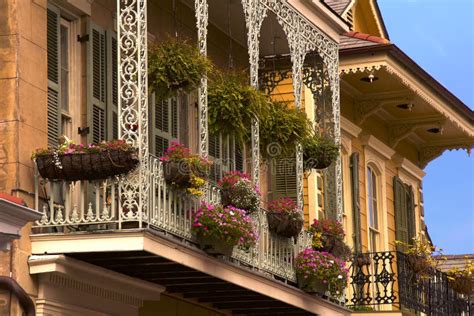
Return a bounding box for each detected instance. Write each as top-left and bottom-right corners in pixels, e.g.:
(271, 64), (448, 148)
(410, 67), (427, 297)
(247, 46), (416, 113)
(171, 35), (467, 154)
(0, 0), (474, 316)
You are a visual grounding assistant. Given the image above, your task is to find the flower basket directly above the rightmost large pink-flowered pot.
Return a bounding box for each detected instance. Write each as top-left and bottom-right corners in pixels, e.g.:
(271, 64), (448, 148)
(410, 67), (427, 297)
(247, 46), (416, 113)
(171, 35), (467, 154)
(309, 219), (351, 261)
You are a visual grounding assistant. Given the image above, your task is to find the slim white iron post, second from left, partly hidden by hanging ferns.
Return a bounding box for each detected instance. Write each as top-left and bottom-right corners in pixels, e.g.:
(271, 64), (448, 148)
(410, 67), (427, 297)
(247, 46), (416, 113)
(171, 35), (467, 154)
(194, 0), (209, 157)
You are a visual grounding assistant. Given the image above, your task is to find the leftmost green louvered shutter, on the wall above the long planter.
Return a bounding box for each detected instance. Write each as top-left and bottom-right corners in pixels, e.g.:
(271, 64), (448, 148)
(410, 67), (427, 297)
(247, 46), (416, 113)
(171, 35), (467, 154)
(47, 6), (61, 146)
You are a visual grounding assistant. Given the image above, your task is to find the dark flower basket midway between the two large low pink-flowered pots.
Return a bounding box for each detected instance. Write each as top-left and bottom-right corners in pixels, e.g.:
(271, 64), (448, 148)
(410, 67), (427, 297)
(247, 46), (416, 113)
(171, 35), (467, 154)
(267, 197), (304, 239)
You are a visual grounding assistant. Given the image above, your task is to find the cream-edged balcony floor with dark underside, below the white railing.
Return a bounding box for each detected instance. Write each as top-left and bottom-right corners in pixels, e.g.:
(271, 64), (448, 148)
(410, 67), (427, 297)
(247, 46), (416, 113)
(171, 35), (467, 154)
(32, 230), (349, 315)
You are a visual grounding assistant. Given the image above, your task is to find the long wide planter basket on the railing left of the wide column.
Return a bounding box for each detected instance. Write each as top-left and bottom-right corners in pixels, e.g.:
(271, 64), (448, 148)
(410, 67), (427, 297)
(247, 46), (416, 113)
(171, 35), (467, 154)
(32, 137), (138, 181)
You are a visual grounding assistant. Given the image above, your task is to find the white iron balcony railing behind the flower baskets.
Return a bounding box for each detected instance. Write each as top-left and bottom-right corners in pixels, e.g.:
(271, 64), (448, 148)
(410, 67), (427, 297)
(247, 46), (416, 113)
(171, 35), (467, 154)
(34, 156), (310, 282)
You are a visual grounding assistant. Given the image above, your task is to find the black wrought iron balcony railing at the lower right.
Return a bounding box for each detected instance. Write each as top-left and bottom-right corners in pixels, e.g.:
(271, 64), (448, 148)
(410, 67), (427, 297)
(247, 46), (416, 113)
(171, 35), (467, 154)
(347, 251), (470, 316)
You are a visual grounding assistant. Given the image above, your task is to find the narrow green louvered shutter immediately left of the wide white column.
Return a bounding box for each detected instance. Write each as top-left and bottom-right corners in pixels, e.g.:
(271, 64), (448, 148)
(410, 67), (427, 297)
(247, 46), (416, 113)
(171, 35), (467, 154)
(106, 31), (119, 140)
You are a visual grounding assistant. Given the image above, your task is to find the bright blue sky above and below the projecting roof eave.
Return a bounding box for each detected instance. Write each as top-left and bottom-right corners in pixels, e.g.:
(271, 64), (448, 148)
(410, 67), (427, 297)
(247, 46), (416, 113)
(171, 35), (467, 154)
(378, 0), (474, 254)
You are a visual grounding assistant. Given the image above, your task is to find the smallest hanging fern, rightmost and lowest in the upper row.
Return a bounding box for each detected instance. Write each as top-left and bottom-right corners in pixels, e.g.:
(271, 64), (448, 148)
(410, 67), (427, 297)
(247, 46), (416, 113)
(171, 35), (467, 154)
(302, 135), (339, 170)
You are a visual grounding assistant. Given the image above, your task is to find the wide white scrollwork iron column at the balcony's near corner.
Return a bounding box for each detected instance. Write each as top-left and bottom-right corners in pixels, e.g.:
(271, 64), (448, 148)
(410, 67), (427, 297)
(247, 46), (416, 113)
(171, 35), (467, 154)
(117, 0), (149, 227)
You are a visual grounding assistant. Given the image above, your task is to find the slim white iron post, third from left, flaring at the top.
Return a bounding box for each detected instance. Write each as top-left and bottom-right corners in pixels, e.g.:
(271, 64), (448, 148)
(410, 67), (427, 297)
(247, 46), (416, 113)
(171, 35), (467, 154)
(242, 0), (267, 187)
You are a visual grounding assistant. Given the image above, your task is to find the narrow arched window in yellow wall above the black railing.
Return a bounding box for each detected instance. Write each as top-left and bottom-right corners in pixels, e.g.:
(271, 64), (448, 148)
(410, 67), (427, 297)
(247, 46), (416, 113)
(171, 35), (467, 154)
(367, 167), (379, 251)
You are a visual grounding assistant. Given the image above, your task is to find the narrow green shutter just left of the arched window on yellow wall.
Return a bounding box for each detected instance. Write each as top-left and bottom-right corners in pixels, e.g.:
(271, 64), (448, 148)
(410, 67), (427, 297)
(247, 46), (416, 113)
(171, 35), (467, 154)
(350, 153), (362, 252)
